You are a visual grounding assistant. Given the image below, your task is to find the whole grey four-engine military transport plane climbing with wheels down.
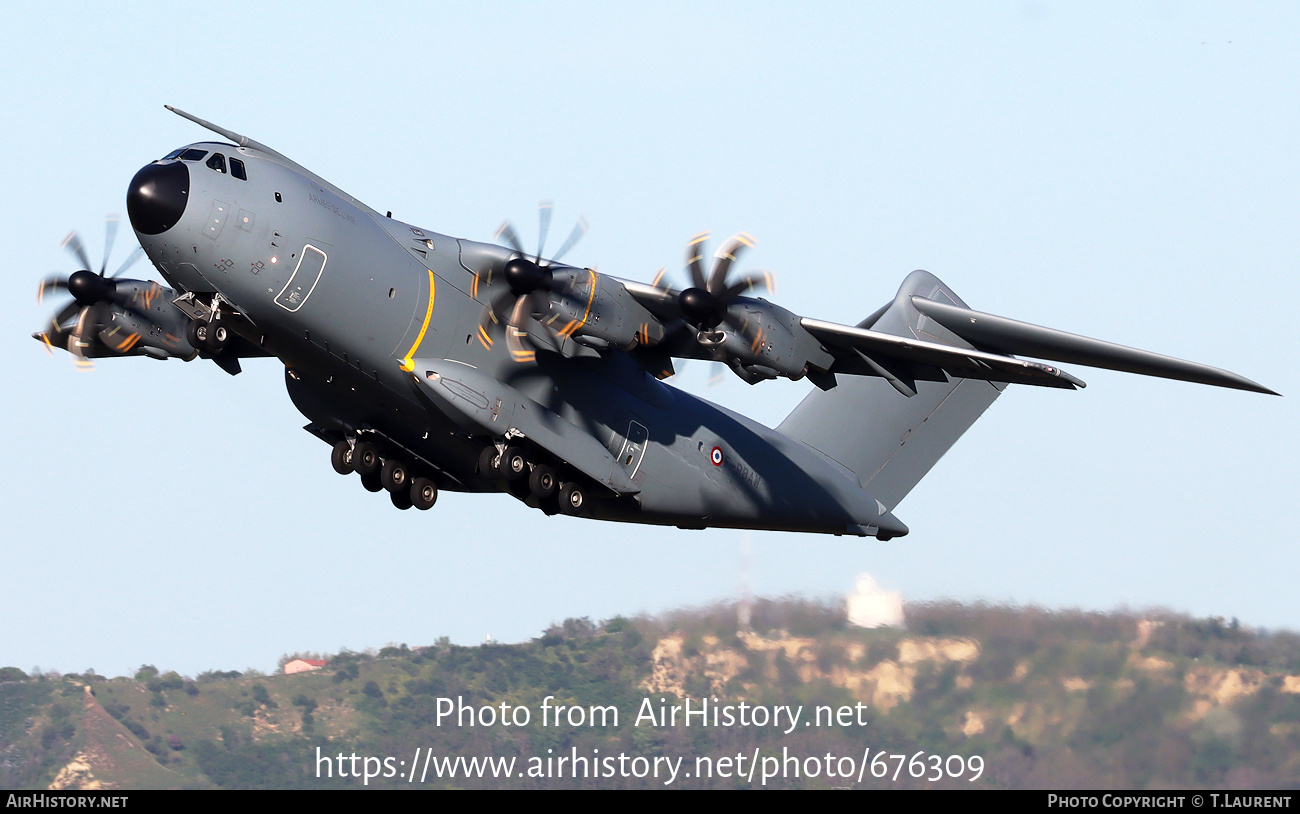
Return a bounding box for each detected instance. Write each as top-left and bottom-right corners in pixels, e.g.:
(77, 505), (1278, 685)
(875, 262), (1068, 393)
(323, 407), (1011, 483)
(35, 108), (1271, 540)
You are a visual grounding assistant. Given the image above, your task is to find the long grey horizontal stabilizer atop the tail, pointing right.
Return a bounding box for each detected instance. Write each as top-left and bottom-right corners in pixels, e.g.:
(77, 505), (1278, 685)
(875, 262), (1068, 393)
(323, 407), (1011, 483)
(911, 295), (1278, 395)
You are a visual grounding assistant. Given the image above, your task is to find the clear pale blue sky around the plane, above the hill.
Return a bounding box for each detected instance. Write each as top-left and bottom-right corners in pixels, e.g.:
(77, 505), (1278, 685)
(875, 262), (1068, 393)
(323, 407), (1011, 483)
(0, 3), (1300, 675)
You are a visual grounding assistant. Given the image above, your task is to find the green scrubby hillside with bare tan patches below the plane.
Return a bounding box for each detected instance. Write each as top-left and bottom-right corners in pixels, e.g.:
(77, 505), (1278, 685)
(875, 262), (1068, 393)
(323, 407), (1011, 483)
(0, 599), (1300, 791)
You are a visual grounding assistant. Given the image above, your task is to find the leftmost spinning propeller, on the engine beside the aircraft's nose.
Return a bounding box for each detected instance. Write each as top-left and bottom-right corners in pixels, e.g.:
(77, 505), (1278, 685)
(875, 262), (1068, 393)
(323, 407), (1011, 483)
(35, 215), (148, 369)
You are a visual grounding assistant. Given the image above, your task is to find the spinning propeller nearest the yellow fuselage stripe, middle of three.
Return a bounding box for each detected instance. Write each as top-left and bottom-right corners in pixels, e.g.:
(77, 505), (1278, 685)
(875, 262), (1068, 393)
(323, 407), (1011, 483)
(471, 200), (588, 361)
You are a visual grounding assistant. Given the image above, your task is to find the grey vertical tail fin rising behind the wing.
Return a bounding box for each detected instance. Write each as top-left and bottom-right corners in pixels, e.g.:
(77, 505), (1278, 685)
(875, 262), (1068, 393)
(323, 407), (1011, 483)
(777, 272), (1006, 510)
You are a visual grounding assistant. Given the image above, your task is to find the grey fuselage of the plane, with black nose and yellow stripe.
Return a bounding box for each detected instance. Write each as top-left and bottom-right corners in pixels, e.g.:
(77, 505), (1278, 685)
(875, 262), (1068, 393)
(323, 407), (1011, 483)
(129, 142), (905, 534)
